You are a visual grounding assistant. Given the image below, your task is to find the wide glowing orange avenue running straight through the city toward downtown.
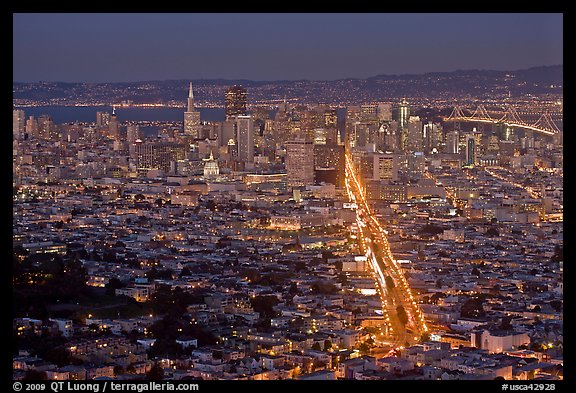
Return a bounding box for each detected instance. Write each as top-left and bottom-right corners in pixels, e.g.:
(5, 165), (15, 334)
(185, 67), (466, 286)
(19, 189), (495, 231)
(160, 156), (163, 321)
(346, 153), (428, 347)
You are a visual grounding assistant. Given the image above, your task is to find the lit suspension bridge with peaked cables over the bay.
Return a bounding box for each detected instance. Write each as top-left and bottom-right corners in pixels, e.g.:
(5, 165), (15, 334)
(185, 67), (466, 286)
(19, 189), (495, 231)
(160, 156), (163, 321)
(444, 105), (561, 135)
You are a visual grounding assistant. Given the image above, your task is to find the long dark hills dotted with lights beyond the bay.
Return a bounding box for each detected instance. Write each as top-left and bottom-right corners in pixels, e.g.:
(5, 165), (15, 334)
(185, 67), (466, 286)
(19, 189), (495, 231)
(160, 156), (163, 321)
(13, 65), (563, 105)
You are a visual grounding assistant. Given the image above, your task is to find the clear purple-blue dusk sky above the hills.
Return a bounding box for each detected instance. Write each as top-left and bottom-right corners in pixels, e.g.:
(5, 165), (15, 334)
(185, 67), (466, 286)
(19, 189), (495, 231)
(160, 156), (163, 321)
(13, 13), (563, 82)
